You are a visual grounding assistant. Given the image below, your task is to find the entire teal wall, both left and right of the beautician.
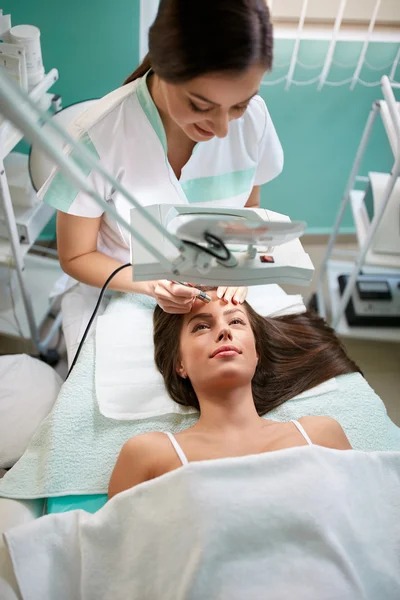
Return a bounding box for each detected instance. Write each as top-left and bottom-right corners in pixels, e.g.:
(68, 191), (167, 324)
(2, 0), (400, 233)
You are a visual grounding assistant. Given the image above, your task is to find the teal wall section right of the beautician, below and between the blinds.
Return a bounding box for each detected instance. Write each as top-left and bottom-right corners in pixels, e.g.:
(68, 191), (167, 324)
(261, 40), (400, 233)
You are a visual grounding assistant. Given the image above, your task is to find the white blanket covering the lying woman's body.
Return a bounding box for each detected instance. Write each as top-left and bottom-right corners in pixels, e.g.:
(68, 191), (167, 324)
(5, 446), (400, 600)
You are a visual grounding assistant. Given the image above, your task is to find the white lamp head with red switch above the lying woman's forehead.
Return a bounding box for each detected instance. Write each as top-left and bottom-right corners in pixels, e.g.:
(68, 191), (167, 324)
(131, 204), (314, 286)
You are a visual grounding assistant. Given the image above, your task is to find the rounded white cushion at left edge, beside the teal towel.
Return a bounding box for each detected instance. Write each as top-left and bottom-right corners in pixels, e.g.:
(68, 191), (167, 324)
(0, 354), (62, 468)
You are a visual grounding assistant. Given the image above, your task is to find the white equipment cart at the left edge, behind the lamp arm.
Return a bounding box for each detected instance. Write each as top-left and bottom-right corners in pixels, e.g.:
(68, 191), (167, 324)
(0, 69), (62, 364)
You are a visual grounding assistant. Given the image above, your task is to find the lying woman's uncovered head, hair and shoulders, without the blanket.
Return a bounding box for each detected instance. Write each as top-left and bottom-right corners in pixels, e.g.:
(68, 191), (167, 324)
(109, 288), (359, 497)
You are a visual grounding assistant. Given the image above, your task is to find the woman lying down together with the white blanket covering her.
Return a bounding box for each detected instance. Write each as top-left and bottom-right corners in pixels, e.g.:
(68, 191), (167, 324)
(0, 291), (400, 600)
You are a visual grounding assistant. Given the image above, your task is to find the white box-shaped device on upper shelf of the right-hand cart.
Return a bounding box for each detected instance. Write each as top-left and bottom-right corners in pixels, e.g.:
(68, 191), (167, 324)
(364, 173), (400, 255)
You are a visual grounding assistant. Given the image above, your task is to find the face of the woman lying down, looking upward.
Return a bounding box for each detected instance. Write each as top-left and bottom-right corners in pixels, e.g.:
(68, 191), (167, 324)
(177, 291), (258, 389)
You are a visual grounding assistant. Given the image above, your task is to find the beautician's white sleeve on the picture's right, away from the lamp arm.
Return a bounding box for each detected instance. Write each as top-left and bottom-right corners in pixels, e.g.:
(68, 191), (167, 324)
(254, 98), (283, 185)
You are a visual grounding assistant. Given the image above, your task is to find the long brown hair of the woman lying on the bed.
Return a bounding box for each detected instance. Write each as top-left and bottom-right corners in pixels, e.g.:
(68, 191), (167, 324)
(154, 286), (361, 415)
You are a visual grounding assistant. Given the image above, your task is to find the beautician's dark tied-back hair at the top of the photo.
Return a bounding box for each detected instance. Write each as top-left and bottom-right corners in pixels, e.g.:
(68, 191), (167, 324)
(124, 0), (273, 83)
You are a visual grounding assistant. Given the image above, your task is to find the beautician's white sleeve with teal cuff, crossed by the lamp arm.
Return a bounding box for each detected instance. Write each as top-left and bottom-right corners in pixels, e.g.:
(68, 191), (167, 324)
(38, 125), (109, 217)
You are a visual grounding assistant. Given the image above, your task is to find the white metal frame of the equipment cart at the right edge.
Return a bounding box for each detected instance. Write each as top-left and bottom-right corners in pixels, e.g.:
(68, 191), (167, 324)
(309, 75), (400, 342)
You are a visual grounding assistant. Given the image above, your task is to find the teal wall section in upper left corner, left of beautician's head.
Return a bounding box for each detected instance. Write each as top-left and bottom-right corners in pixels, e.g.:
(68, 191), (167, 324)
(1, 0), (140, 106)
